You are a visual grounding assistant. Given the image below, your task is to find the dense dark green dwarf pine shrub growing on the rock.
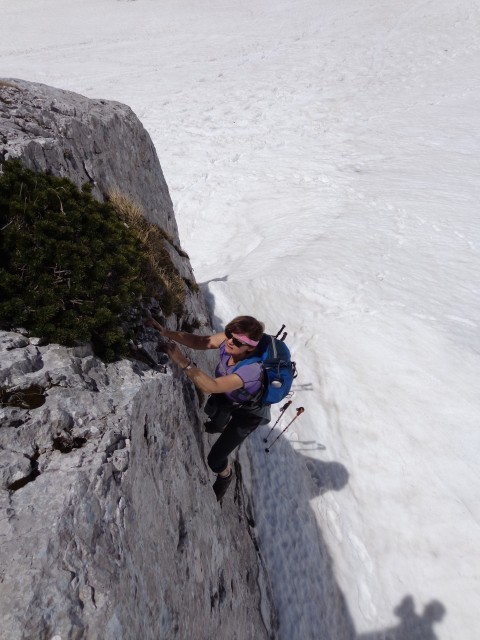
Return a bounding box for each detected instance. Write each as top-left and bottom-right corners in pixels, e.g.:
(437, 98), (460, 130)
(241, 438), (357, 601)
(0, 161), (146, 360)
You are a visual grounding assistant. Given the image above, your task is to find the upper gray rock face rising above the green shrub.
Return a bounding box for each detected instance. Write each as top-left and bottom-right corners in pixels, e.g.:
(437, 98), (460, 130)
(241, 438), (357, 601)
(0, 79), (178, 242)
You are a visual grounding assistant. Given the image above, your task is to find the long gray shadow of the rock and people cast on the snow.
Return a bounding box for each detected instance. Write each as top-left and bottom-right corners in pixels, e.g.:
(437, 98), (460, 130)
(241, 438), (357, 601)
(242, 425), (446, 640)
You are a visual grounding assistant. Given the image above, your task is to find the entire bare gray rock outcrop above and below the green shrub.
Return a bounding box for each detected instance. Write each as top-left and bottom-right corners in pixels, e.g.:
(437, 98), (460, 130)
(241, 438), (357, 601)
(0, 81), (274, 640)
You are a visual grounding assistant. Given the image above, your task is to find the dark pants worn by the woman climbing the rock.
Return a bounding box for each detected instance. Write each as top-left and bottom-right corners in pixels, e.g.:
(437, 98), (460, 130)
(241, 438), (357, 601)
(205, 394), (270, 473)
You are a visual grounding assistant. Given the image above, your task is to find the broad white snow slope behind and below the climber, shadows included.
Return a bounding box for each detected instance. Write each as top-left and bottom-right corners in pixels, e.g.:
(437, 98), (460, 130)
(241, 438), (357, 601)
(0, 0), (480, 640)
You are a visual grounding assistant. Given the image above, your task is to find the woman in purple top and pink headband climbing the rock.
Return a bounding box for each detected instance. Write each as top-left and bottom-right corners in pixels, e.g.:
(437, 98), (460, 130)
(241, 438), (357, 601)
(146, 316), (270, 500)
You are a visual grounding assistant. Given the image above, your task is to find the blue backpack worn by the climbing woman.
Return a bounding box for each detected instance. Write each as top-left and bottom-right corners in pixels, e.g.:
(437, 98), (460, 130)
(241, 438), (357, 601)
(232, 325), (297, 407)
